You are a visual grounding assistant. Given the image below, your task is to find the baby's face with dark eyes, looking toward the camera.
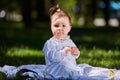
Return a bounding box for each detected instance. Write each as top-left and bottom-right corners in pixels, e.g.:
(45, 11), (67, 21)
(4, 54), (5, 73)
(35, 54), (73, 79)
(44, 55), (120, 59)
(51, 16), (71, 40)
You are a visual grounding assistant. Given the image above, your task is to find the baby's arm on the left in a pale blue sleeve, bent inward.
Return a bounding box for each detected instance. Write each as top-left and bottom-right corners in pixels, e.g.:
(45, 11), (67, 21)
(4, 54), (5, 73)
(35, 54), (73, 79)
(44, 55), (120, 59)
(43, 42), (66, 62)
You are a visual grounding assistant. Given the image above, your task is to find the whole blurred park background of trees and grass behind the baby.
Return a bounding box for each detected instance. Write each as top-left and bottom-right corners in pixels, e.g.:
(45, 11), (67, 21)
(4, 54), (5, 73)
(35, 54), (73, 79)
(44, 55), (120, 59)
(0, 0), (120, 69)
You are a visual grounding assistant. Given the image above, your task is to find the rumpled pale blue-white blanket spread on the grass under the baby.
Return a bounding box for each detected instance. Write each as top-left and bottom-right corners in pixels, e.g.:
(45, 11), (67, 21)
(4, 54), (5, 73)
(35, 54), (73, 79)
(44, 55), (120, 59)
(0, 64), (120, 80)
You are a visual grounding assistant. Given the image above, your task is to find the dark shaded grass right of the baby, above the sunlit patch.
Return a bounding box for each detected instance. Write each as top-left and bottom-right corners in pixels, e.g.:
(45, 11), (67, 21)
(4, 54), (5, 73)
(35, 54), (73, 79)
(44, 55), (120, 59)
(70, 27), (120, 50)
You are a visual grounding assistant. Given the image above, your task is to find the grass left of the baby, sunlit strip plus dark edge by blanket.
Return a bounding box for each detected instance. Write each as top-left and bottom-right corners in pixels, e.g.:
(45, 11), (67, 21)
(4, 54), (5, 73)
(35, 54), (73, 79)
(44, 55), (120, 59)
(0, 47), (45, 66)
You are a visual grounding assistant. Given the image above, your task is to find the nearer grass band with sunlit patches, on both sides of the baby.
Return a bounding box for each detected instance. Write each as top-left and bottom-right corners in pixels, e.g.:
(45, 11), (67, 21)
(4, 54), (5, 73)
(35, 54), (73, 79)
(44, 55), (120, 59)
(0, 47), (120, 69)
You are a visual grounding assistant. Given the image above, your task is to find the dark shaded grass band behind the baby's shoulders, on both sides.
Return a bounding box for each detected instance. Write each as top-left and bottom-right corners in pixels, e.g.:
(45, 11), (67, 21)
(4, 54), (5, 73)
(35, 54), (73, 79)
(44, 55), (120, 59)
(0, 27), (120, 50)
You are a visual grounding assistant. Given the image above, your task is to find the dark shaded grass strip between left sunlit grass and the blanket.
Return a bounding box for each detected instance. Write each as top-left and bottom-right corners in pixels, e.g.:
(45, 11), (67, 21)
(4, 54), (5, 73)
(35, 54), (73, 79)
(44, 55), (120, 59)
(0, 55), (45, 66)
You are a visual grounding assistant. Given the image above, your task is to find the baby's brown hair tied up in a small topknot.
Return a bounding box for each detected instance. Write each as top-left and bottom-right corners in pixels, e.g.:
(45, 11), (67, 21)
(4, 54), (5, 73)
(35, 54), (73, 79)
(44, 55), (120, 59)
(49, 4), (72, 25)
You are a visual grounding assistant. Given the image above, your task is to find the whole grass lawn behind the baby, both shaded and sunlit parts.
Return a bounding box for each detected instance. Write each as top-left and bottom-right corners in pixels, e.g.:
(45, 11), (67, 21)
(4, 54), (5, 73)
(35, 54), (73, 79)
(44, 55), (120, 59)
(0, 27), (120, 69)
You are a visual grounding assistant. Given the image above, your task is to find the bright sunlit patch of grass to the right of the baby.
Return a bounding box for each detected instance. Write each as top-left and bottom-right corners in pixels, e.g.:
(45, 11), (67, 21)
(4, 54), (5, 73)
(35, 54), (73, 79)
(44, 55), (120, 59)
(77, 47), (120, 69)
